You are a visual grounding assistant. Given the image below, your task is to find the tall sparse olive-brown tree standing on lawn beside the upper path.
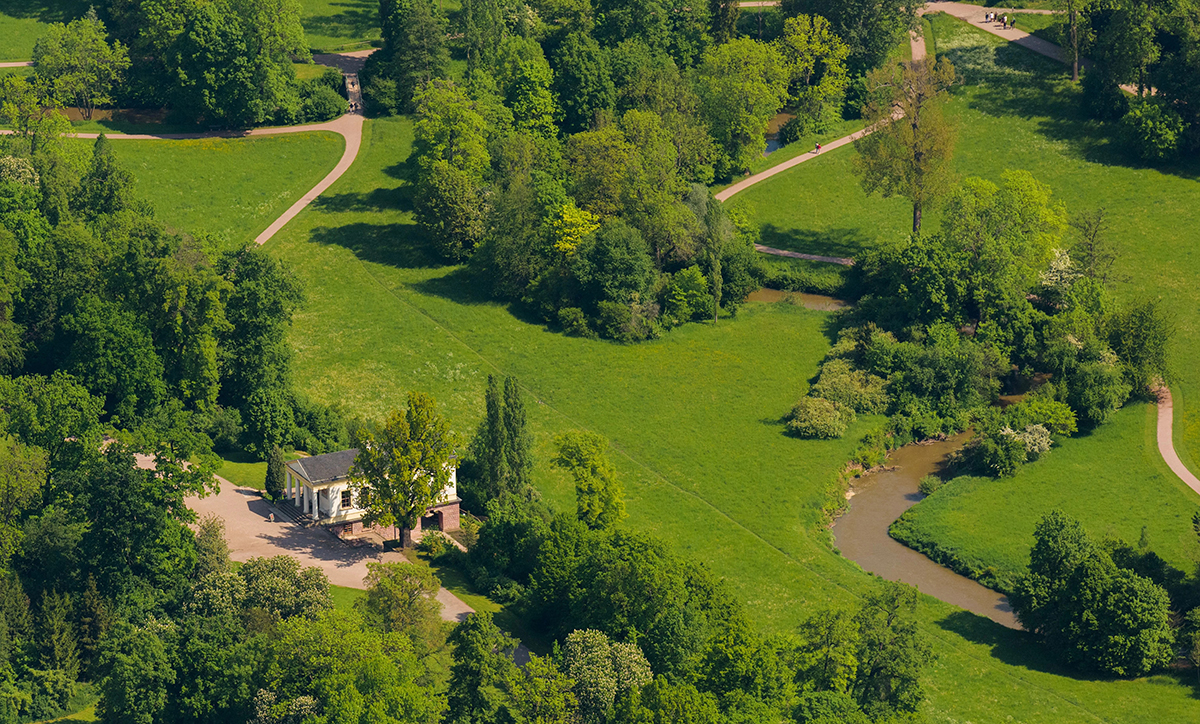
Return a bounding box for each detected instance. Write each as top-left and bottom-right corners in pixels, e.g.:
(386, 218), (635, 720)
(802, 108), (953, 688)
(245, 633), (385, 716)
(854, 55), (955, 234)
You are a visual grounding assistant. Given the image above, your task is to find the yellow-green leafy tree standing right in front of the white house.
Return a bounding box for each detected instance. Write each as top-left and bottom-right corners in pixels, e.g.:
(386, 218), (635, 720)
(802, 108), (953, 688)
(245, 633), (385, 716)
(350, 393), (456, 544)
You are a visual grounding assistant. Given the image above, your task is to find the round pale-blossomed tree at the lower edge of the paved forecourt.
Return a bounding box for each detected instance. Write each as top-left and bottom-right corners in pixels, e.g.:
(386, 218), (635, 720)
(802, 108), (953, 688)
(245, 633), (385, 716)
(238, 556), (334, 621)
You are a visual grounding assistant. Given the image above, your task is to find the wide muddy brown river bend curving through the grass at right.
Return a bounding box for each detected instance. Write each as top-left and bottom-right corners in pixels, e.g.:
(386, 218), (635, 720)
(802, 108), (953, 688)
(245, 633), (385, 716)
(833, 436), (1020, 628)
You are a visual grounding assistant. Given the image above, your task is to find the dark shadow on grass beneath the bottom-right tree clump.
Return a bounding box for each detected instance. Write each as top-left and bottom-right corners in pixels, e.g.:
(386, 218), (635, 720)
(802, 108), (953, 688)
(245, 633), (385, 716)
(936, 611), (1200, 698)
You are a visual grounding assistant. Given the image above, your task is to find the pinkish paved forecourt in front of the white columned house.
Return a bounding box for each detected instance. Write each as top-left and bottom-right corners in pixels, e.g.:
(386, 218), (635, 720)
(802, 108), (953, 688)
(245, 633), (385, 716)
(187, 482), (473, 621)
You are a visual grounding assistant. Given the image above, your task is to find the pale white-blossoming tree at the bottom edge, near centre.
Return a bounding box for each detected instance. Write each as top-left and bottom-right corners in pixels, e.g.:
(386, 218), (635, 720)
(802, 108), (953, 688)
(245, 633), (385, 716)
(563, 629), (653, 723)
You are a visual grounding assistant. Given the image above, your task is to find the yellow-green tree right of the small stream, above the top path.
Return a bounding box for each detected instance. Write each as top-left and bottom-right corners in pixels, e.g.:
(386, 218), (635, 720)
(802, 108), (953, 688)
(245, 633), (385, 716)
(778, 14), (850, 134)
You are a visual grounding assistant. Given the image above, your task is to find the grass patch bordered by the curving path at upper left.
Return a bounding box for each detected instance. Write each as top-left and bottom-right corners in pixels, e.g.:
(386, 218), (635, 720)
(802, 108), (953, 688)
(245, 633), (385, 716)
(103, 132), (346, 247)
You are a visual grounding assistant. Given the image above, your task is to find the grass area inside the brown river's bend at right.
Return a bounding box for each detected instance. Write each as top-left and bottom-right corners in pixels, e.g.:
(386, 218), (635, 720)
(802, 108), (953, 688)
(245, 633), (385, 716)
(893, 403), (1200, 590)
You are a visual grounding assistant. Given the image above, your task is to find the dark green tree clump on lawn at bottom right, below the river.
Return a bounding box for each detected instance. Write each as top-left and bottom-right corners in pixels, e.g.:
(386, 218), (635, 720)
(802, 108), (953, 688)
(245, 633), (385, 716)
(1009, 510), (1174, 676)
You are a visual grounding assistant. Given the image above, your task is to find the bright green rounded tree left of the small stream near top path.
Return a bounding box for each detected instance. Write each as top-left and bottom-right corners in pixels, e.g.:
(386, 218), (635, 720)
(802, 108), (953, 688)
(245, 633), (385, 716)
(696, 38), (787, 176)
